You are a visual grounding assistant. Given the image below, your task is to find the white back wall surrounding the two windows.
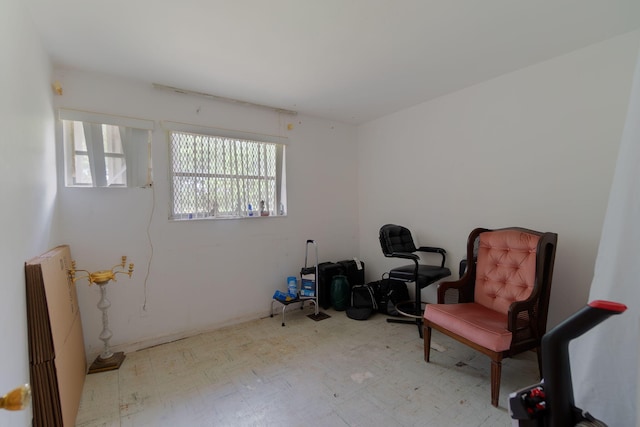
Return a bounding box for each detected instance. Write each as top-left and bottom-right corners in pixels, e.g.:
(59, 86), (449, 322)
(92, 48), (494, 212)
(54, 69), (358, 359)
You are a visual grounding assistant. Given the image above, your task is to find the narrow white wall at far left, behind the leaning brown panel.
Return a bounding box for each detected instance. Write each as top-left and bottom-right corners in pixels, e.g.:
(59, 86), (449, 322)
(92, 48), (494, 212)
(0, 0), (56, 427)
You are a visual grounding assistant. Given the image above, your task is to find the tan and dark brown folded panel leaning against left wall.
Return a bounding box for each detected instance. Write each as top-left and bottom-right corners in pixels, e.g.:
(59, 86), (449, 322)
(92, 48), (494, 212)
(25, 245), (87, 426)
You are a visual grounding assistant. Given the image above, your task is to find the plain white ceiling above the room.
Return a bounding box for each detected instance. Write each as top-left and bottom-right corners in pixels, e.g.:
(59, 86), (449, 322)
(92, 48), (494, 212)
(26, 0), (640, 124)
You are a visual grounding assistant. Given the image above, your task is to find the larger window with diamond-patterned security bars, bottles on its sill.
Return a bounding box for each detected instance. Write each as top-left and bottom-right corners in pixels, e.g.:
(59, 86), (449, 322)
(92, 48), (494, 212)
(169, 131), (286, 219)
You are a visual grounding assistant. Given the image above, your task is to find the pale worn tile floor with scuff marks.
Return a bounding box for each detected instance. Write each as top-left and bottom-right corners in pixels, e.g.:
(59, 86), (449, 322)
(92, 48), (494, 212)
(76, 307), (537, 427)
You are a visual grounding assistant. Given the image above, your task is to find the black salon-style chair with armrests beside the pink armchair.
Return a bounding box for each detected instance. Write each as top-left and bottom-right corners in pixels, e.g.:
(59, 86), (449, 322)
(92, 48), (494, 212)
(380, 224), (451, 338)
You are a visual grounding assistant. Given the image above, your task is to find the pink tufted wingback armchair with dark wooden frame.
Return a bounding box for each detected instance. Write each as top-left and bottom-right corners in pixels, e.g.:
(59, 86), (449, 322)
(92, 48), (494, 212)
(424, 227), (558, 406)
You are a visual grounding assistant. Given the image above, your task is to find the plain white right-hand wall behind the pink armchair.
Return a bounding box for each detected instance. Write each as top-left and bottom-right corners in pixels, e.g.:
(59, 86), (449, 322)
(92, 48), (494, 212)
(358, 31), (640, 326)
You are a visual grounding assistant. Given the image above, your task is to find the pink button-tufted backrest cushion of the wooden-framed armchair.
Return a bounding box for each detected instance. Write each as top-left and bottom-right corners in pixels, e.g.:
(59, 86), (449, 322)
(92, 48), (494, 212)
(475, 229), (540, 313)
